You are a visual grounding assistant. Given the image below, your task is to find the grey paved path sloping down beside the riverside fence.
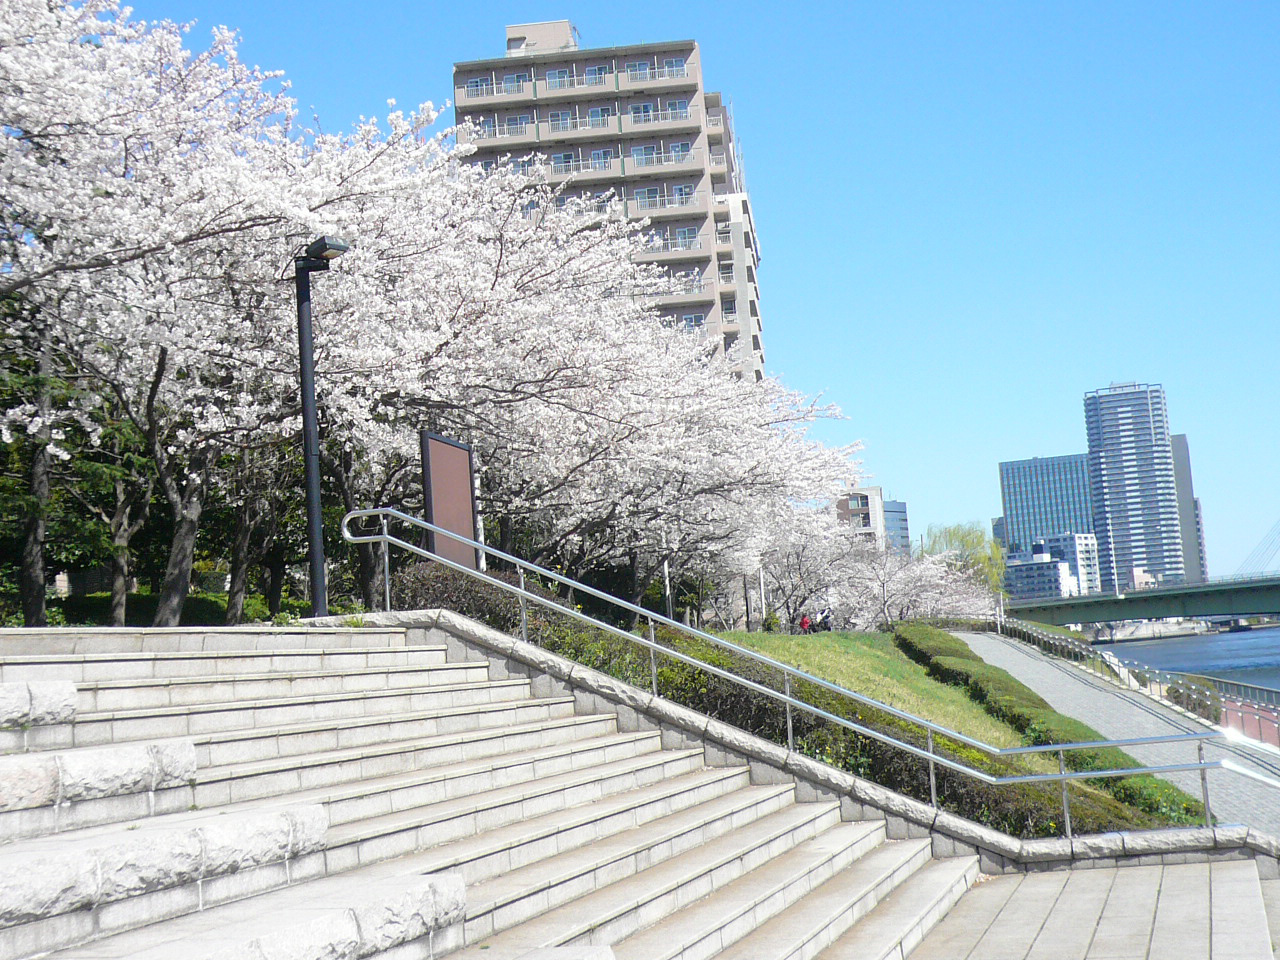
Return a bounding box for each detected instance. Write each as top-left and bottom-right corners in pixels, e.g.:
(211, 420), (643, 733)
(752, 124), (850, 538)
(956, 634), (1280, 837)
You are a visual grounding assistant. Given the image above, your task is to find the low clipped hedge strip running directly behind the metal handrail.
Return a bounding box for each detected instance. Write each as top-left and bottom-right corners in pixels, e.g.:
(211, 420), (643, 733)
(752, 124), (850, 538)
(404, 564), (1203, 837)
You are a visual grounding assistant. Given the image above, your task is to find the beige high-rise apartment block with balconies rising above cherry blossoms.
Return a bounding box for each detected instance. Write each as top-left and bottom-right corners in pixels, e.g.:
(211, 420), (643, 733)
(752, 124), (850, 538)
(453, 20), (764, 379)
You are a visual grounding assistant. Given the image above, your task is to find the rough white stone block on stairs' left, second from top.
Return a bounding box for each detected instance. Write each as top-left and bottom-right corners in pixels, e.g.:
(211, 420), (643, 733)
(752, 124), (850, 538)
(0, 740), (196, 812)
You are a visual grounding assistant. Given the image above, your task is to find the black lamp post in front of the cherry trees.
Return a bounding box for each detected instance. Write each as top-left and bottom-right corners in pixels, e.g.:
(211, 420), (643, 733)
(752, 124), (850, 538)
(293, 237), (349, 617)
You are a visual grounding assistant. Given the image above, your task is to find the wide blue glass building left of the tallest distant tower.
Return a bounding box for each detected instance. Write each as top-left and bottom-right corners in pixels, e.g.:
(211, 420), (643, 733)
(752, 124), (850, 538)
(1000, 453), (1093, 550)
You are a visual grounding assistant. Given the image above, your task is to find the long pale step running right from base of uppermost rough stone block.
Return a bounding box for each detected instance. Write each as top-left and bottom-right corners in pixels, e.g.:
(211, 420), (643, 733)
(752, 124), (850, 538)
(51, 680), (560, 763)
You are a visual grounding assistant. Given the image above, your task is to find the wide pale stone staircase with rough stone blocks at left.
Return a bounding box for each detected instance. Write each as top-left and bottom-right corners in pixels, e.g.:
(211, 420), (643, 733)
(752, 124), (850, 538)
(0, 616), (1274, 960)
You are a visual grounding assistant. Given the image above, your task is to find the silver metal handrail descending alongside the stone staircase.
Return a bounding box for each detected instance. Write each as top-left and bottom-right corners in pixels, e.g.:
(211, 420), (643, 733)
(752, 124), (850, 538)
(342, 507), (1280, 837)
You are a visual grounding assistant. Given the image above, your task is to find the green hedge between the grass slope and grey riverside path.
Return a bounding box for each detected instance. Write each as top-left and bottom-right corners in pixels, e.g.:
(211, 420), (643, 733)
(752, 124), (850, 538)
(893, 623), (1204, 823)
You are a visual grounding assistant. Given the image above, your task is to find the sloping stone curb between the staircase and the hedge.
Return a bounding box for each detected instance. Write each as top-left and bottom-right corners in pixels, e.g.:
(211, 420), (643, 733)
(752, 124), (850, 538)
(317, 609), (1280, 879)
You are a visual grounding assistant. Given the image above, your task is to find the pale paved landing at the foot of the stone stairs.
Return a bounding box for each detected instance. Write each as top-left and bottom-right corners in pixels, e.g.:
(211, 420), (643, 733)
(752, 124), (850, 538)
(911, 860), (1272, 960)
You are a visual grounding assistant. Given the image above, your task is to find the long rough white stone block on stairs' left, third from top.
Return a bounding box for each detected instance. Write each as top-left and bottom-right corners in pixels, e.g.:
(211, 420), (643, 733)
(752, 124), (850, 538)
(0, 804), (329, 927)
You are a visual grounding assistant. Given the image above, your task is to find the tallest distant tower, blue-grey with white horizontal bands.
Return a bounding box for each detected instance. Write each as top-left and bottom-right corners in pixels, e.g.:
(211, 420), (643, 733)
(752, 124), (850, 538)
(1084, 383), (1187, 593)
